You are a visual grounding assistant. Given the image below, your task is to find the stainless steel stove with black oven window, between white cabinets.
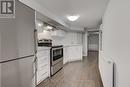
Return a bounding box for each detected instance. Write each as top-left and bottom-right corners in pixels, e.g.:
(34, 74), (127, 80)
(51, 46), (63, 76)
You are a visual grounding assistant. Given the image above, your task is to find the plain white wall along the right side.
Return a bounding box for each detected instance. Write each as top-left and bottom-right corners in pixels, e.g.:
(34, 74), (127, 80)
(102, 0), (130, 87)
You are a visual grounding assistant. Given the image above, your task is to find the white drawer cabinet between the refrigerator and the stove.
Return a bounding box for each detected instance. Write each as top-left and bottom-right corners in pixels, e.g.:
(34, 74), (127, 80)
(37, 47), (50, 85)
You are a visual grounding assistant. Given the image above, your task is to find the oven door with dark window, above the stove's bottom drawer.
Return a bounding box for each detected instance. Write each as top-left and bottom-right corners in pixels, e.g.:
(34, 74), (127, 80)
(51, 47), (63, 65)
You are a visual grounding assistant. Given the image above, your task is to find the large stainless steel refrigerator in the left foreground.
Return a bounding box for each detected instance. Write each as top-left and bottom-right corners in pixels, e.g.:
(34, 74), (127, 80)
(0, 0), (36, 87)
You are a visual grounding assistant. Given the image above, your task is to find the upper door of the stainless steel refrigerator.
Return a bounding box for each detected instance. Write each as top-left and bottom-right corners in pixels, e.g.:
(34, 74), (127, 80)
(0, 0), (35, 61)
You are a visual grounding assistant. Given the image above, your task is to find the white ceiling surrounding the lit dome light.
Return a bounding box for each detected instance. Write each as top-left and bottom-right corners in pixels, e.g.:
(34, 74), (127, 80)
(37, 0), (108, 28)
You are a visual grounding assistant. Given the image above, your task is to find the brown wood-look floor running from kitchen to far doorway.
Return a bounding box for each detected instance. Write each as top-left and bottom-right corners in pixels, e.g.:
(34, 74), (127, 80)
(38, 52), (103, 87)
